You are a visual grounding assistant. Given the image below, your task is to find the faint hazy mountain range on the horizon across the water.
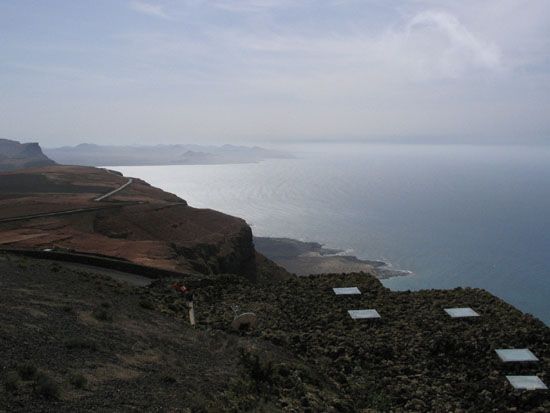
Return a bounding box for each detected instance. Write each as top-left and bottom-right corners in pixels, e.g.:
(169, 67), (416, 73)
(44, 143), (293, 166)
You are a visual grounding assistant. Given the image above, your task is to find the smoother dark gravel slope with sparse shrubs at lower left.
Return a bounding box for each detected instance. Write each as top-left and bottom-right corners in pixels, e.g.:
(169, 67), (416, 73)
(0, 255), (246, 412)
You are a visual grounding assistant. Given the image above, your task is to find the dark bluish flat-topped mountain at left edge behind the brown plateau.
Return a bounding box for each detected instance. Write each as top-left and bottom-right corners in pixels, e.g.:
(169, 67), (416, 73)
(0, 139), (55, 171)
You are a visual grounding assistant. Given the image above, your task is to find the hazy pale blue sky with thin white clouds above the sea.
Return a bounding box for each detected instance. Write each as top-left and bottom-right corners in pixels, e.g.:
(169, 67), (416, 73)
(0, 0), (550, 146)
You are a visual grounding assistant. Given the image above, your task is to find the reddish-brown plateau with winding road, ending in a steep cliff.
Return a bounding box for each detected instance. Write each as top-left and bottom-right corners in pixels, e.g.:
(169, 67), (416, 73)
(0, 166), (288, 279)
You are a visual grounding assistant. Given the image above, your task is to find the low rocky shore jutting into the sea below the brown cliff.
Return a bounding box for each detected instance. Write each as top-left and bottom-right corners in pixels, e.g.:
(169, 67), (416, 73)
(254, 237), (412, 279)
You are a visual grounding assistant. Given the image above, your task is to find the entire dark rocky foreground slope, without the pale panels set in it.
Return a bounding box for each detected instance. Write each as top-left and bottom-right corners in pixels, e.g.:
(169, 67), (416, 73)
(0, 254), (550, 412)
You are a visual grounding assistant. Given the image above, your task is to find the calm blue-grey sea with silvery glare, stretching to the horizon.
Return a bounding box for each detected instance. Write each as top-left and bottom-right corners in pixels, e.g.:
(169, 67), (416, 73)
(113, 144), (550, 324)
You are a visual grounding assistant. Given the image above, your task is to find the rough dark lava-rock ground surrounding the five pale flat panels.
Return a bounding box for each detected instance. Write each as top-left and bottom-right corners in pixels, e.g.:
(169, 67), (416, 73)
(153, 274), (550, 412)
